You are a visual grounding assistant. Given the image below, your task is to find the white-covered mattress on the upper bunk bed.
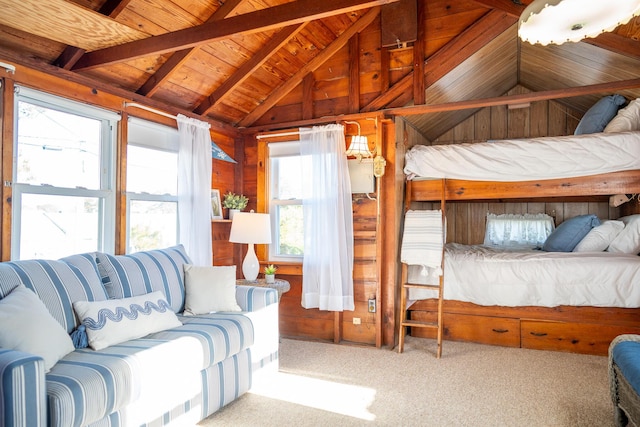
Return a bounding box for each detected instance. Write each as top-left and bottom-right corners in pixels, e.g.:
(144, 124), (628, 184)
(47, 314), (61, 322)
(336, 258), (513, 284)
(404, 132), (640, 181)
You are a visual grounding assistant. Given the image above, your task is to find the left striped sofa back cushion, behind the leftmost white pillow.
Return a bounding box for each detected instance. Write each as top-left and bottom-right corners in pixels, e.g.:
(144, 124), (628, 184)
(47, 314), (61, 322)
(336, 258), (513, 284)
(0, 254), (108, 333)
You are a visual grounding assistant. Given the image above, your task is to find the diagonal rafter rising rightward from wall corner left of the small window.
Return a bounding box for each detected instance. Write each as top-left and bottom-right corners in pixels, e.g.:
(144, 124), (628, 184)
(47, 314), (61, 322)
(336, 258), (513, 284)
(239, 7), (380, 126)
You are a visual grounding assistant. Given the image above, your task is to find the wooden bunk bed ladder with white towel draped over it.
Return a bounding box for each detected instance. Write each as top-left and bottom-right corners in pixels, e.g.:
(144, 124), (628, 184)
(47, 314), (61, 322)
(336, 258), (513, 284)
(398, 178), (446, 359)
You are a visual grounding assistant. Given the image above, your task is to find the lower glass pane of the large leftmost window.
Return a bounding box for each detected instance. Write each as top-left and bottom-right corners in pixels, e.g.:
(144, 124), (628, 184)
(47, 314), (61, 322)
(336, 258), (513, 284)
(20, 193), (100, 259)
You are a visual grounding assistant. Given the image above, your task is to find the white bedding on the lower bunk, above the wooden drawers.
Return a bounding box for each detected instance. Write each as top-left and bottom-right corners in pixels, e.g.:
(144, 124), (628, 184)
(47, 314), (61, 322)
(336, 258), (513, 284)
(409, 243), (640, 308)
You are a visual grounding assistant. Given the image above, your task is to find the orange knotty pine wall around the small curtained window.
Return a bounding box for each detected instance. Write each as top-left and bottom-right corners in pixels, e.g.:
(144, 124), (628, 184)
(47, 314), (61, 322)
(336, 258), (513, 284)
(242, 119), (397, 346)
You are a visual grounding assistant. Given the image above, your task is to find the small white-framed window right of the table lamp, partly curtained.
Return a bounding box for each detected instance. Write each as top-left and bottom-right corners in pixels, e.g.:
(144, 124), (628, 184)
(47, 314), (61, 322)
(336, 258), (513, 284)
(268, 142), (304, 262)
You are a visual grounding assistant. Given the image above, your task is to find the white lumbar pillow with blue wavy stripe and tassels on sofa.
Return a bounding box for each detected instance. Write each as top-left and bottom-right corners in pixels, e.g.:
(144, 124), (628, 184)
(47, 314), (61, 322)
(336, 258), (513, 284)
(73, 291), (182, 350)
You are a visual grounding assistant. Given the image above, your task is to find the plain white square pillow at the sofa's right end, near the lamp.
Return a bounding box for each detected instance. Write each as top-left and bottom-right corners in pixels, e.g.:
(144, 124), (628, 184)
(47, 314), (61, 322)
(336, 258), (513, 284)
(184, 264), (242, 316)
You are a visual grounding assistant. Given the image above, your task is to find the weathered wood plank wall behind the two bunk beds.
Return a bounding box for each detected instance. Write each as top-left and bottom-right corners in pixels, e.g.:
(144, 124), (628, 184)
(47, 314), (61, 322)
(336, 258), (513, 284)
(408, 86), (620, 244)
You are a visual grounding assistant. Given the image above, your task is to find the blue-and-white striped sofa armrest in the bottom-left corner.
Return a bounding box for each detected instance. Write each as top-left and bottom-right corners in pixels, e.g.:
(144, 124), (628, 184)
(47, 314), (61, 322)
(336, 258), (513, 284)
(0, 348), (47, 427)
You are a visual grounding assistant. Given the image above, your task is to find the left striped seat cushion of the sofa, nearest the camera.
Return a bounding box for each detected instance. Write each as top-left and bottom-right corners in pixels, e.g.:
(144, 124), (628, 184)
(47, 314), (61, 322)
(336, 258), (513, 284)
(46, 337), (202, 427)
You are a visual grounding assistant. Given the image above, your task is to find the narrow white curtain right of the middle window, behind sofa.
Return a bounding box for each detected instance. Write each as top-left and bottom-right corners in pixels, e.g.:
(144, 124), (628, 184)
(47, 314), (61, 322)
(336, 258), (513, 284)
(177, 114), (213, 266)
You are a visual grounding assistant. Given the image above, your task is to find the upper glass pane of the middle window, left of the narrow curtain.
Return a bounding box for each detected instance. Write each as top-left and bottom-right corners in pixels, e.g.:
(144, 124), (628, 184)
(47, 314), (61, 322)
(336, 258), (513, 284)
(127, 145), (178, 195)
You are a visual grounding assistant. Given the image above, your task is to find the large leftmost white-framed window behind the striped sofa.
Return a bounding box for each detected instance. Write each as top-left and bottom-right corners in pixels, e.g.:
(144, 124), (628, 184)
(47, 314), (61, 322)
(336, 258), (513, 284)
(11, 87), (120, 259)
